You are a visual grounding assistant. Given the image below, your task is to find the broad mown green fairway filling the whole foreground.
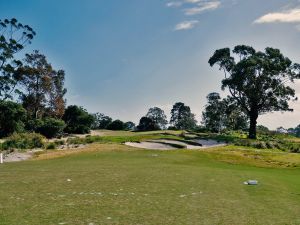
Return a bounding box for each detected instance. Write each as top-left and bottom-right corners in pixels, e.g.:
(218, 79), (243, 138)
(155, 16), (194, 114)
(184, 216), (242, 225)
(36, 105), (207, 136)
(0, 144), (300, 225)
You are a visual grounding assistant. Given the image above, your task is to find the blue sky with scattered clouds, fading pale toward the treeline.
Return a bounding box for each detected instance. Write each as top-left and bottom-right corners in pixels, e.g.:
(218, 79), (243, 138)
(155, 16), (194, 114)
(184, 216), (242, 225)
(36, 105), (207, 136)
(0, 0), (300, 129)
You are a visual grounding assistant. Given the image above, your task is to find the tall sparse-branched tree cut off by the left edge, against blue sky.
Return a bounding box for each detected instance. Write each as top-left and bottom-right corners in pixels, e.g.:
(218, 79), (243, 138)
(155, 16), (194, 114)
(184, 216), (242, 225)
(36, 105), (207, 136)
(0, 18), (35, 100)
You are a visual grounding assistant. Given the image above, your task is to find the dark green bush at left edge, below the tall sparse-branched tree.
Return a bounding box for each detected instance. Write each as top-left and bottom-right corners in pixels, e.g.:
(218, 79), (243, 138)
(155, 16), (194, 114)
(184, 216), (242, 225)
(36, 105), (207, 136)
(0, 101), (26, 137)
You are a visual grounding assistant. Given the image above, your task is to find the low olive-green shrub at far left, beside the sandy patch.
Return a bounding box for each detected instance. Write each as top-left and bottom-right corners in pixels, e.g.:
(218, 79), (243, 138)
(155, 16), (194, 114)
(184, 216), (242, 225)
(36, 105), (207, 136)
(2, 133), (44, 150)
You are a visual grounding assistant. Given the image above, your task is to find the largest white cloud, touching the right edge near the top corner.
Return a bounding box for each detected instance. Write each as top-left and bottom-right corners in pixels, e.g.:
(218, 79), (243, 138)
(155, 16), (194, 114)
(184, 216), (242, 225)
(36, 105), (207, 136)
(254, 8), (300, 24)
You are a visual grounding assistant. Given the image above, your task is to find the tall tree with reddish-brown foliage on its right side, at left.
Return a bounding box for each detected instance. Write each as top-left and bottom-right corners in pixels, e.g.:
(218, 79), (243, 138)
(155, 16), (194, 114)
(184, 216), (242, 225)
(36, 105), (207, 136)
(19, 50), (67, 119)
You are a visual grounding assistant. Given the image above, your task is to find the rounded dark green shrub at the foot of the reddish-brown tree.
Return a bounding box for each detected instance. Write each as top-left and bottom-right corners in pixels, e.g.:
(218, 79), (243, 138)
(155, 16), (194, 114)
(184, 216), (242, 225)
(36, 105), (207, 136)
(35, 118), (65, 138)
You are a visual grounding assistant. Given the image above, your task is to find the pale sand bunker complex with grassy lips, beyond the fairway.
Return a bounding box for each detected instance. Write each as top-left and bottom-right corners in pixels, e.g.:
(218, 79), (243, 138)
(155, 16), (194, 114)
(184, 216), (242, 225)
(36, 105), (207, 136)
(125, 139), (227, 150)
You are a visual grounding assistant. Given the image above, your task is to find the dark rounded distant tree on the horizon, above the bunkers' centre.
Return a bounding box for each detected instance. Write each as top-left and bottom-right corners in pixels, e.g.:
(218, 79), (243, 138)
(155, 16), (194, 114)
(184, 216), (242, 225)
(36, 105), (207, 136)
(170, 102), (197, 130)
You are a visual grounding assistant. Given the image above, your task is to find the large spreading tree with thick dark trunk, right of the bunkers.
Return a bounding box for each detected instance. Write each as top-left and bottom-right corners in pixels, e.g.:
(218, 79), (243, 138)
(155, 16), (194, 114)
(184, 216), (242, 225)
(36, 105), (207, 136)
(209, 45), (300, 139)
